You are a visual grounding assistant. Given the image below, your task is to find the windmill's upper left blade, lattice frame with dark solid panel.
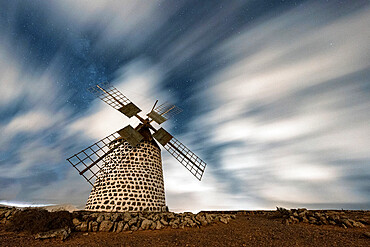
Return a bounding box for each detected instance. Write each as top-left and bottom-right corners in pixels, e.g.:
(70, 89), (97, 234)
(87, 82), (141, 118)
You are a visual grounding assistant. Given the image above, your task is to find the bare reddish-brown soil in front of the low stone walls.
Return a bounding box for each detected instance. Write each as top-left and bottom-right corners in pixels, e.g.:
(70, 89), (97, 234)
(0, 211), (370, 247)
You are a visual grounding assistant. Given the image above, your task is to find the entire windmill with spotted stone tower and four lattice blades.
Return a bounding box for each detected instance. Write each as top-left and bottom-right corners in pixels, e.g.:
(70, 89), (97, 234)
(67, 83), (206, 212)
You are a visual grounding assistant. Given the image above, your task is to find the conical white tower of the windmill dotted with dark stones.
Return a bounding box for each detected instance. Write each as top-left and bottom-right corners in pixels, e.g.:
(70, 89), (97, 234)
(85, 127), (166, 212)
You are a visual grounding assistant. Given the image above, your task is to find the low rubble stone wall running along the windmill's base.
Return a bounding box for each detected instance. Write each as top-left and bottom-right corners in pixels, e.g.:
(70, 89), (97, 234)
(0, 208), (236, 239)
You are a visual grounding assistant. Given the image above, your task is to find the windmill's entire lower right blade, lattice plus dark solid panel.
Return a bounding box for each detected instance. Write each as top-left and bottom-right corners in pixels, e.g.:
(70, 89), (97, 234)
(153, 128), (207, 181)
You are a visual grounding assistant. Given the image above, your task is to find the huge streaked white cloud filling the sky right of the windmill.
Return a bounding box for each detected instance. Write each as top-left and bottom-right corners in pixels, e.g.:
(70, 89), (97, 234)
(192, 5), (370, 207)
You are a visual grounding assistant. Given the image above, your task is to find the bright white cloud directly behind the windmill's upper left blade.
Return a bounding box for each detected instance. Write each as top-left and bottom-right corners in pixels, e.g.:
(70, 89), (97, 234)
(68, 59), (171, 140)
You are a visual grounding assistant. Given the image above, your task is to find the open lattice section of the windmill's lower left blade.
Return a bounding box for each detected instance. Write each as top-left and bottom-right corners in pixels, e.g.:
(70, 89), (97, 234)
(67, 132), (120, 186)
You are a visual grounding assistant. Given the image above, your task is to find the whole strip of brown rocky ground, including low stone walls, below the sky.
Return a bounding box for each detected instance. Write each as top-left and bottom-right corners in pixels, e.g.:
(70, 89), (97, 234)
(0, 208), (370, 246)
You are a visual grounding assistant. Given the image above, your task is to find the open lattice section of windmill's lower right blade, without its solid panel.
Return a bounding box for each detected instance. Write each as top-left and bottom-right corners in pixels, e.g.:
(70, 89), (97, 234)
(164, 137), (207, 180)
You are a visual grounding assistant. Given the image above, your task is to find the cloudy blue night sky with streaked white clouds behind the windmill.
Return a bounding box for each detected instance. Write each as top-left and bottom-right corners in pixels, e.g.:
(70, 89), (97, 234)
(0, 0), (370, 211)
